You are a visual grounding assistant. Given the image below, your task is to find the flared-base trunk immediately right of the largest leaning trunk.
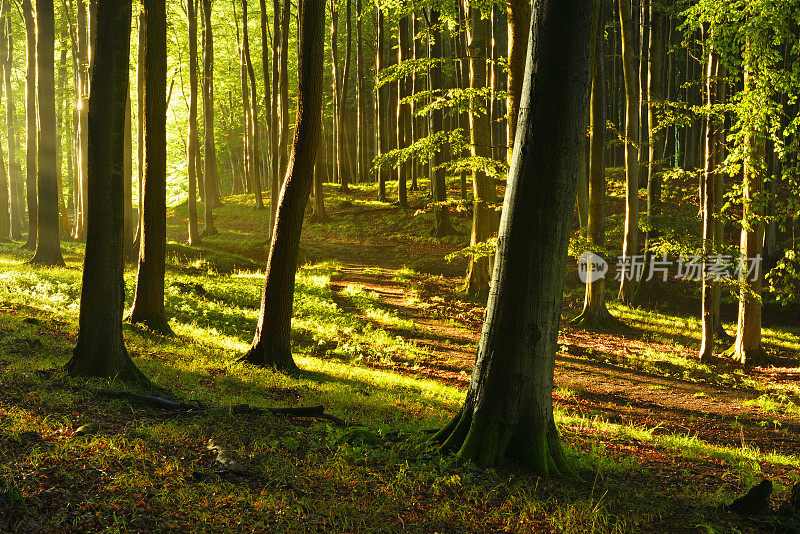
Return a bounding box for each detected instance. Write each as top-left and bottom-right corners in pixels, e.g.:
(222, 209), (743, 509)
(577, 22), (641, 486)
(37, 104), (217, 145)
(571, 2), (618, 329)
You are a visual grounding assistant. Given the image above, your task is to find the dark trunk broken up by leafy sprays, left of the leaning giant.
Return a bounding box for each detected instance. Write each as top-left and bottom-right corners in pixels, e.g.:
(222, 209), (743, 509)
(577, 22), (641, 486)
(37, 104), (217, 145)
(428, 9), (456, 237)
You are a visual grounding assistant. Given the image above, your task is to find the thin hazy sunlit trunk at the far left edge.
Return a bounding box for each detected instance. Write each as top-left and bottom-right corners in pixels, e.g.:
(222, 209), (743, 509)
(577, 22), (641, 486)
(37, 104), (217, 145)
(0, 15), (24, 240)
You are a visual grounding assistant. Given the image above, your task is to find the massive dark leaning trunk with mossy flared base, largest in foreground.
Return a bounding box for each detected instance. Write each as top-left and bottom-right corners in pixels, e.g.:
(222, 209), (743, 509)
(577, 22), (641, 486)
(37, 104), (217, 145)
(436, 0), (598, 475)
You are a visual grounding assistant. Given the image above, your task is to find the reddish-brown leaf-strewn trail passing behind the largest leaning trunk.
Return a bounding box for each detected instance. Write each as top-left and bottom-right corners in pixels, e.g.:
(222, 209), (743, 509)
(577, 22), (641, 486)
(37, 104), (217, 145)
(331, 264), (800, 454)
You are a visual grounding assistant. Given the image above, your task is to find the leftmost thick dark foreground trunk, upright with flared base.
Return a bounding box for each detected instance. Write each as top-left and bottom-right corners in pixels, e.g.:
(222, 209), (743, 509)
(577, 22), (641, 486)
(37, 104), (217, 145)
(66, 2), (147, 381)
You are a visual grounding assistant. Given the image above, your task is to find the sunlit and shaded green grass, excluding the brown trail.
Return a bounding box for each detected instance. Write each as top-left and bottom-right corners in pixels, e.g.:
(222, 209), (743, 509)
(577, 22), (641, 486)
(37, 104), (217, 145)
(0, 185), (800, 533)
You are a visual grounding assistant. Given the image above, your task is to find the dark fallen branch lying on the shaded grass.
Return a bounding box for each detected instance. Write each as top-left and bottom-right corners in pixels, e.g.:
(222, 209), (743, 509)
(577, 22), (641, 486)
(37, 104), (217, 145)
(97, 389), (348, 426)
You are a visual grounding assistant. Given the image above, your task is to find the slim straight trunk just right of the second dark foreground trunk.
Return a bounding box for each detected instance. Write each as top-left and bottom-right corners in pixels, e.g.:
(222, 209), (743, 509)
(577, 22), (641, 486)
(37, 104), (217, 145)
(186, 0), (200, 246)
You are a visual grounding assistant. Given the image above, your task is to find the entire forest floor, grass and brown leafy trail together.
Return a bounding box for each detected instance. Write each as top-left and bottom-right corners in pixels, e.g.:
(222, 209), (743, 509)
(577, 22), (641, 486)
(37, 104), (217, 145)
(0, 179), (800, 533)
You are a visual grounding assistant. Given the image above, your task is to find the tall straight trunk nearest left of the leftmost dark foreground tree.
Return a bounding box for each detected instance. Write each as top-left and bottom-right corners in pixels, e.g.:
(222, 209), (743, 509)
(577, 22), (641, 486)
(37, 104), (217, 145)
(31, 0), (64, 266)
